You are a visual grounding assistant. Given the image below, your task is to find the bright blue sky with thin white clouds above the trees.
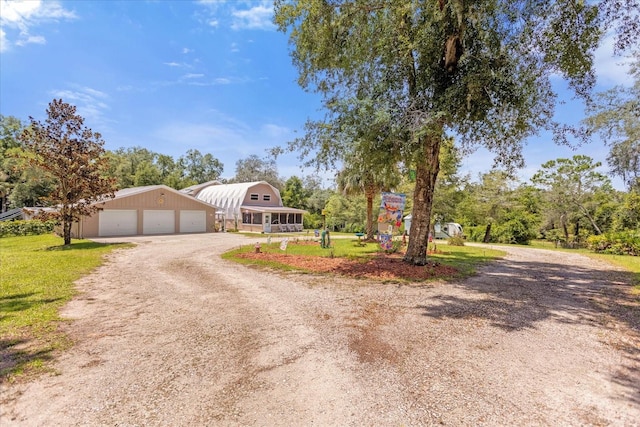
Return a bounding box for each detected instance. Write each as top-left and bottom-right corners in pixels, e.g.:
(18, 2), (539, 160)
(0, 0), (631, 189)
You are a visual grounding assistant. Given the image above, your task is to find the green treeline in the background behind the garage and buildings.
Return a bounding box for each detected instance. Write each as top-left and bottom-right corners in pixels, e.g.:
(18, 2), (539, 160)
(0, 117), (640, 254)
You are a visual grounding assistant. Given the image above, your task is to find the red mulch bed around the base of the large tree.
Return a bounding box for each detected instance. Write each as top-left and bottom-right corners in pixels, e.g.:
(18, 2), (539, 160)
(239, 252), (458, 281)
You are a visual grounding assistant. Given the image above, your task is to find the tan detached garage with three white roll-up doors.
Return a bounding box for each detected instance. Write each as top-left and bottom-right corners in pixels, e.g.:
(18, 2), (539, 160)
(72, 185), (217, 238)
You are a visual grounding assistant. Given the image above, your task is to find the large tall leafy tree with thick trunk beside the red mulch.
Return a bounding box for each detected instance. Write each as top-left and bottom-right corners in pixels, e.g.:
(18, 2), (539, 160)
(275, 0), (615, 264)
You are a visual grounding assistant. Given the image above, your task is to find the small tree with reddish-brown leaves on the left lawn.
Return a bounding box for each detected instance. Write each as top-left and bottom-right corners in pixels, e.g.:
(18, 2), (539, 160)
(20, 99), (116, 245)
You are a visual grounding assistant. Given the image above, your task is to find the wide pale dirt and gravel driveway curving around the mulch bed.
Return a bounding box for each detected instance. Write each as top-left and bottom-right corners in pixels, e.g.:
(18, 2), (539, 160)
(0, 234), (640, 427)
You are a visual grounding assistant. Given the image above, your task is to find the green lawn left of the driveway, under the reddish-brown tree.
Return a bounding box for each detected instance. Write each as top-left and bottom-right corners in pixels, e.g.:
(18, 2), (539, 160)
(0, 235), (125, 382)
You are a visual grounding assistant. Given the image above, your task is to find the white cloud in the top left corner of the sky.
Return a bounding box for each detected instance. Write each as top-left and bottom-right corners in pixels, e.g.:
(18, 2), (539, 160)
(0, 0), (77, 52)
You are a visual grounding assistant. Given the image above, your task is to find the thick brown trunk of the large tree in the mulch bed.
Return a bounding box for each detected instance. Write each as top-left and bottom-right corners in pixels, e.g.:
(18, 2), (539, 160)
(404, 132), (442, 265)
